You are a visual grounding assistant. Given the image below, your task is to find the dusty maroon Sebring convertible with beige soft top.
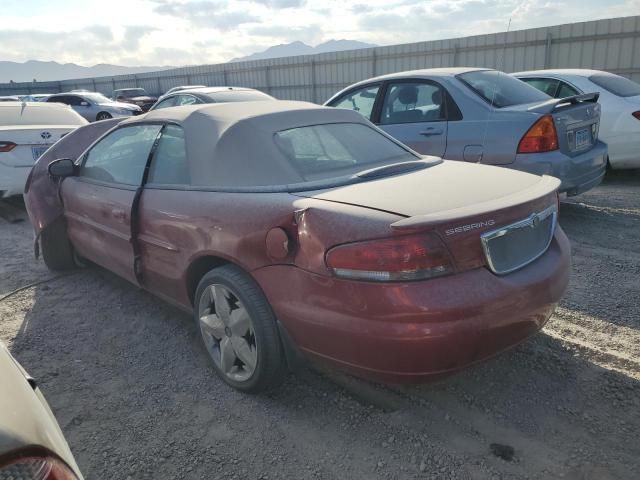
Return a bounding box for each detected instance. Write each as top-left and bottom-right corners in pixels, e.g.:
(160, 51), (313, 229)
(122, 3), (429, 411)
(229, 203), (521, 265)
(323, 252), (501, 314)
(25, 102), (570, 392)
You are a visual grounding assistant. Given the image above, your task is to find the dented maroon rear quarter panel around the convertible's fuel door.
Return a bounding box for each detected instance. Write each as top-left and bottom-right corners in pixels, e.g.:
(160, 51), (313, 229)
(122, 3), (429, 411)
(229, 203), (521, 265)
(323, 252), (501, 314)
(138, 188), (402, 309)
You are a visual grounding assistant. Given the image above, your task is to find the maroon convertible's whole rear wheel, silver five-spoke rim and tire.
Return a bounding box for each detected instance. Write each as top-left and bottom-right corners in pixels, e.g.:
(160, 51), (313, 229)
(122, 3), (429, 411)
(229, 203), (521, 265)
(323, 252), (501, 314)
(194, 265), (287, 393)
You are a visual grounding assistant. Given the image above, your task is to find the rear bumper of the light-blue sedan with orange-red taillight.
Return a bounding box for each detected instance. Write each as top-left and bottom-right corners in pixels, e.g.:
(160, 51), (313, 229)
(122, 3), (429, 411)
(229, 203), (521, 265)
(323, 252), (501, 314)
(505, 141), (607, 196)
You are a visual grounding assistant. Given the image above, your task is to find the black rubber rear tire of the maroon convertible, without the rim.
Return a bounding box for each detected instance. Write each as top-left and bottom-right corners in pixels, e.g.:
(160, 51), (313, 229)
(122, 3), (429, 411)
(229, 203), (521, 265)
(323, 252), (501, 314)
(194, 265), (287, 393)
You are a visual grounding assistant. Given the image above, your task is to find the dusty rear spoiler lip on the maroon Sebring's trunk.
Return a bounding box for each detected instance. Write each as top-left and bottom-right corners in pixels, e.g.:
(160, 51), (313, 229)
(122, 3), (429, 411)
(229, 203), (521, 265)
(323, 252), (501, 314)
(391, 175), (560, 231)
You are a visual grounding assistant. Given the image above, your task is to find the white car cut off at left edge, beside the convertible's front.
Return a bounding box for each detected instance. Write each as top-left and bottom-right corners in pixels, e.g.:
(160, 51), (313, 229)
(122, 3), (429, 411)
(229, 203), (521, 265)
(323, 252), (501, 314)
(0, 102), (87, 198)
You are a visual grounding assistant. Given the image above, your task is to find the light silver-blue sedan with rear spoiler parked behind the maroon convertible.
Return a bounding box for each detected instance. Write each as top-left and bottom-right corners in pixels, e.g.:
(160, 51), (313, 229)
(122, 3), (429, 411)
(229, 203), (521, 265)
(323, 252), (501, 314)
(326, 68), (607, 195)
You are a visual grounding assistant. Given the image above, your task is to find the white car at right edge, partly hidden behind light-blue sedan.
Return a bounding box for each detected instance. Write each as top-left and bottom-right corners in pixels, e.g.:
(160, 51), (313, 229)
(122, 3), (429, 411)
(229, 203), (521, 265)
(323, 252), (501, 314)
(511, 69), (640, 169)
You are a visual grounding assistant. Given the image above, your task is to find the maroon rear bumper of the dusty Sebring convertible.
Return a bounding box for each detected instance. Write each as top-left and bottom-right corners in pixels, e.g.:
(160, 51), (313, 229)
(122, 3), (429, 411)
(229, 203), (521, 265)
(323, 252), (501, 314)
(253, 228), (570, 383)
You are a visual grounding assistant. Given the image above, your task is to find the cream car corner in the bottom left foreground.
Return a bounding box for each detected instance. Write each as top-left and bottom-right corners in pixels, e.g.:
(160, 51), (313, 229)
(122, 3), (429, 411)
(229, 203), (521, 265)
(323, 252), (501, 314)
(0, 342), (82, 480)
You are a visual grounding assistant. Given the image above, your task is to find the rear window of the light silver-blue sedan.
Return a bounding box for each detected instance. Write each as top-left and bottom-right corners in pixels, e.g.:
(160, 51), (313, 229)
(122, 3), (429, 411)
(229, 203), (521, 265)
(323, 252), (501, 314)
(457, 70), (550, 108)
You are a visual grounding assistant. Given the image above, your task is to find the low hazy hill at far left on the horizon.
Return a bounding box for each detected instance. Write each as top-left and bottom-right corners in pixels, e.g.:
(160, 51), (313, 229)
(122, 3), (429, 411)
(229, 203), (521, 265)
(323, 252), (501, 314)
(0, 60), (173, 83)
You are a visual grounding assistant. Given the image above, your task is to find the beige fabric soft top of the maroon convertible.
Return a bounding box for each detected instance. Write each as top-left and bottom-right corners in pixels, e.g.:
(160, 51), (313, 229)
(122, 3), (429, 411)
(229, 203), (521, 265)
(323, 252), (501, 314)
(121, 101), (372, 188)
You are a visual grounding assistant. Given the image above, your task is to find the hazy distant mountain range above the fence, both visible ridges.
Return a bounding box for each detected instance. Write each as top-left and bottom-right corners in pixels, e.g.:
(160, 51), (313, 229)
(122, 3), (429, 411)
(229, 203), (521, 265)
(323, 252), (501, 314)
(0, 40), (376, 83)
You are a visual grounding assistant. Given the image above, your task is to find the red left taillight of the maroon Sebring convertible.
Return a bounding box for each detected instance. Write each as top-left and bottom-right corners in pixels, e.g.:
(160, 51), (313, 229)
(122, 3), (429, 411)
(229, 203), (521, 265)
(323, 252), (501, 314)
(326, 234), (453, 282)
